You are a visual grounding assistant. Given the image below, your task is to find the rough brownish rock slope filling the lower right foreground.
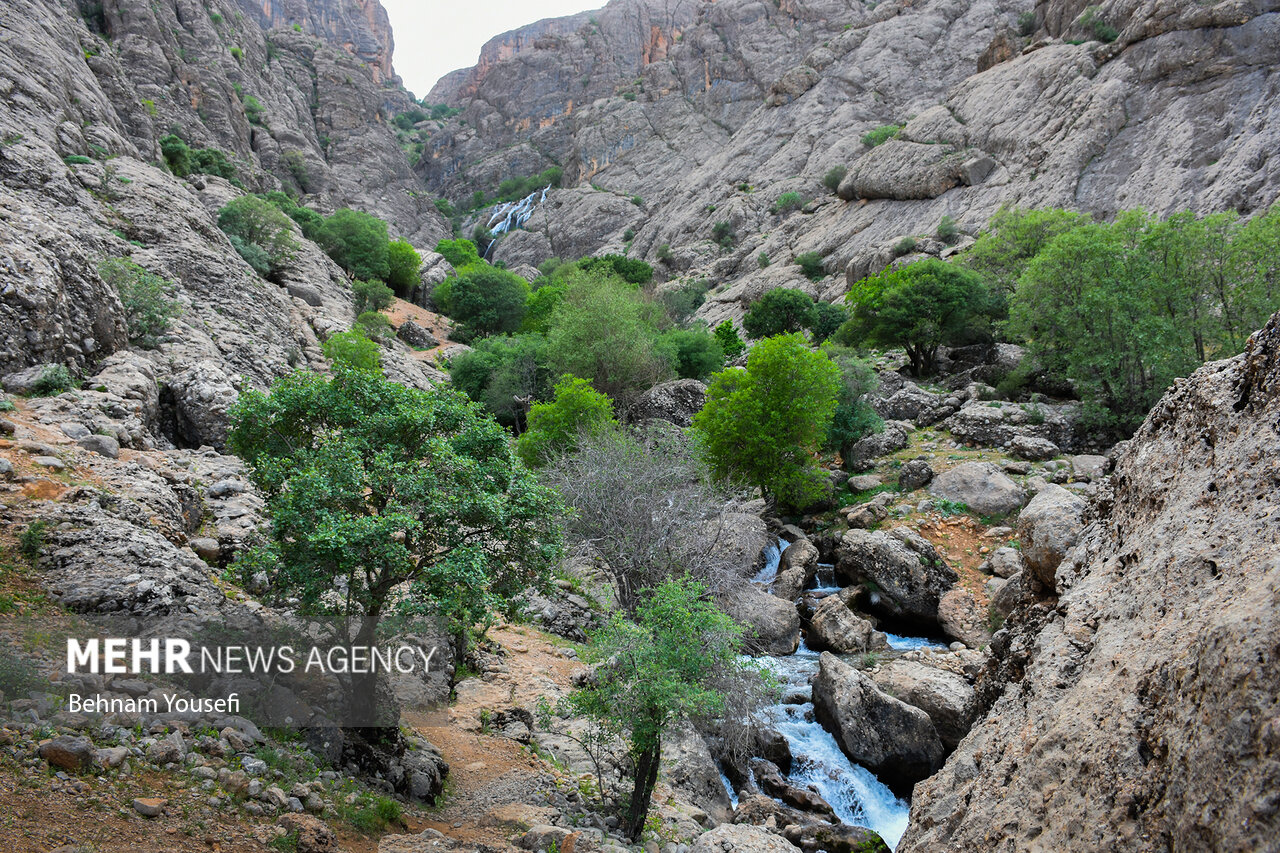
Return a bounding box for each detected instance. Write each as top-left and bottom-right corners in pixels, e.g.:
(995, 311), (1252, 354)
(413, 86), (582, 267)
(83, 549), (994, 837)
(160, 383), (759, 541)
(900, 308), (1280, 852)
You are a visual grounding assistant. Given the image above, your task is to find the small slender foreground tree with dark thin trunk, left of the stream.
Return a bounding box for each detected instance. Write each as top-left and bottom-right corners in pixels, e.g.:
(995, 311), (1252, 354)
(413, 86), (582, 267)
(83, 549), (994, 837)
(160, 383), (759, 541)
(568, 579), (760, 841)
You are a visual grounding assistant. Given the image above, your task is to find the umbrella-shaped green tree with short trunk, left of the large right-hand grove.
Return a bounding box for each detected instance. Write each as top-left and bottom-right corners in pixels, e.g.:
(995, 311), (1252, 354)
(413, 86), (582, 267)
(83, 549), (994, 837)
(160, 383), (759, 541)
(846, 257), (998, 377)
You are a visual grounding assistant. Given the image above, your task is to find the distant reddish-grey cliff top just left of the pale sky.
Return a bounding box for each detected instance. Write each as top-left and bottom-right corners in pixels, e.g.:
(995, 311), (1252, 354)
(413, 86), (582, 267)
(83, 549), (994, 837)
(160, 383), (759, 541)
(237, 0), (396, 83)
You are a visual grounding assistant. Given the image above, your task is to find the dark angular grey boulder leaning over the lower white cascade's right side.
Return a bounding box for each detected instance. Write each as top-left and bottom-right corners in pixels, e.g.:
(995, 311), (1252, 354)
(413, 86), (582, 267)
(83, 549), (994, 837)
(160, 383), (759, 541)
(813, 652), (943, 795)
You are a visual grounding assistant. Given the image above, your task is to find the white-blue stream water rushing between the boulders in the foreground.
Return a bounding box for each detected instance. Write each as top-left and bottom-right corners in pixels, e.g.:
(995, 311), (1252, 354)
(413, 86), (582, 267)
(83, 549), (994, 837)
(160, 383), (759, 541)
(722, 539), (921, 848)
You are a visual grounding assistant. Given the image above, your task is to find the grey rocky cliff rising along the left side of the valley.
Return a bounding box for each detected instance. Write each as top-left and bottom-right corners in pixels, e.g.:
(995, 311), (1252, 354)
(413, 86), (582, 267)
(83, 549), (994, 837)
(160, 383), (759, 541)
(0, 0), (447, 447)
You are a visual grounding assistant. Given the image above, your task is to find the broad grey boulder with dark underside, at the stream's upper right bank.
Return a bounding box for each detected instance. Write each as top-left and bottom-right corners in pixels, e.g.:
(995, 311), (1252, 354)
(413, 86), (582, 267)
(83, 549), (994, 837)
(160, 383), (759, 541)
(836, 528), (959, 625)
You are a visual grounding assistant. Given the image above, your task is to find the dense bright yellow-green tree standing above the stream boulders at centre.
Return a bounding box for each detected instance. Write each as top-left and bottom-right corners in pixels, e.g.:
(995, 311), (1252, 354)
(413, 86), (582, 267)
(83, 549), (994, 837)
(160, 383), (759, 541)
(694, 334), (841, 508)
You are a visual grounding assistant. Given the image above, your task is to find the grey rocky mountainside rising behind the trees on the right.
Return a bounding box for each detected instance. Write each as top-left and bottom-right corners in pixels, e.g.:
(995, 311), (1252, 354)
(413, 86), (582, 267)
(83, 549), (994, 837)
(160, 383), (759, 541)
(419, 0), (1280, 320)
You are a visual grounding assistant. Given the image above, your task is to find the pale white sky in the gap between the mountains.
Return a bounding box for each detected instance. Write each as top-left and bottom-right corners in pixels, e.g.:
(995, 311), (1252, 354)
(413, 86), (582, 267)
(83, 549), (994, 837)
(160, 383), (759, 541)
(383, 0), (604, 97)
